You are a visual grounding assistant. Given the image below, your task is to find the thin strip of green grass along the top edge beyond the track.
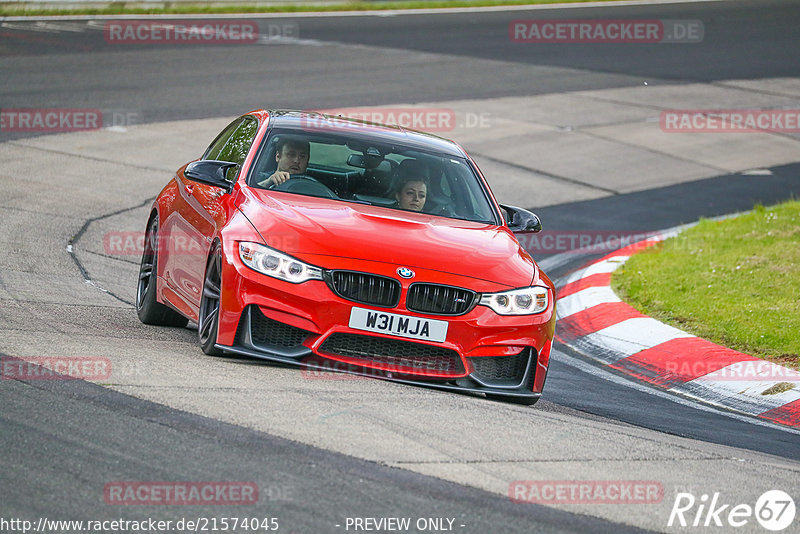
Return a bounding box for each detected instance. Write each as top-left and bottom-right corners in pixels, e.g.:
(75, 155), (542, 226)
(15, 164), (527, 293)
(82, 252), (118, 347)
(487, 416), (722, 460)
(0, 0), (615, 17)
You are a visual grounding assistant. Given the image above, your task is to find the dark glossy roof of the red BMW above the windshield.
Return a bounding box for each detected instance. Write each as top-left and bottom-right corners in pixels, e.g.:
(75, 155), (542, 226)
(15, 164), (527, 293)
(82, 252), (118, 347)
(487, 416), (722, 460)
(256, 109), (466, 158)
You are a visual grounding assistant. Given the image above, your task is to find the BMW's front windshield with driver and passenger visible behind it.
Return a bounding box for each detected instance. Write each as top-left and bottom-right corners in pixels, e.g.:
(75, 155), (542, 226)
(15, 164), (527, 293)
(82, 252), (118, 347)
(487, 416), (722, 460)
(248, 129), (498, 224)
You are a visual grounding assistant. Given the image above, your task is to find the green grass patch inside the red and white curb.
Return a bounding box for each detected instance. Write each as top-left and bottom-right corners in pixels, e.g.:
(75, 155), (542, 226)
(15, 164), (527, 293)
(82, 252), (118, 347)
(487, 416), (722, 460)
(611, 201), (800, 369)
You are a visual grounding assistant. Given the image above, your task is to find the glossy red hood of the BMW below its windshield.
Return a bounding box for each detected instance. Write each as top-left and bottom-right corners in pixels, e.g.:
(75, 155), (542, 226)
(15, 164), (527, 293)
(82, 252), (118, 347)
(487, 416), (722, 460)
(239, 189), (537, 287)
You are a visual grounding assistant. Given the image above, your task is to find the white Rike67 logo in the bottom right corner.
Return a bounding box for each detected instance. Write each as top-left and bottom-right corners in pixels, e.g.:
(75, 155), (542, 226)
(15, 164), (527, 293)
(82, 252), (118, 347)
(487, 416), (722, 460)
(667, 490), (796, 532)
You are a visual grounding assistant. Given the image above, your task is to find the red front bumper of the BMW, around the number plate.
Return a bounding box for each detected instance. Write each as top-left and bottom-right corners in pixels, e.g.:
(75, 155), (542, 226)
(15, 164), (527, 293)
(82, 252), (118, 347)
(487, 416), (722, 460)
(217, 245), (555, 399)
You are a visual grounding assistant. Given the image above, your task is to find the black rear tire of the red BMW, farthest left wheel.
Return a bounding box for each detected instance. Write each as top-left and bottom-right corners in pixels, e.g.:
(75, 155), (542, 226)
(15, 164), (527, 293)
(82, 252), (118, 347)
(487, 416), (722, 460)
(136, 217), (189, 327)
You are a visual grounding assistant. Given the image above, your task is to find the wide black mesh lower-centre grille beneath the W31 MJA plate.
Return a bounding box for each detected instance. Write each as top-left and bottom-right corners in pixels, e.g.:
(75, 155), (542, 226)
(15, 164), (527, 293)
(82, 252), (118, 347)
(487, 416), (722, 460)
(319, 333), (464, 375)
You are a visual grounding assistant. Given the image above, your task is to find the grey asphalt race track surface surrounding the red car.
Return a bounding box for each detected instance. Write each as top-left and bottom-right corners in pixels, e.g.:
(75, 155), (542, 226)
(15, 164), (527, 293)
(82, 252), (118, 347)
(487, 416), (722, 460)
(0, 0), (800, 533)
